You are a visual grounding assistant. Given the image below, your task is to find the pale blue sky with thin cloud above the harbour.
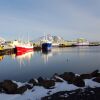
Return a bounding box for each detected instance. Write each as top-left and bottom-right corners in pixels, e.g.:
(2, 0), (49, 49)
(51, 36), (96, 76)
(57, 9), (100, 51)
(0, 0), (100, 41)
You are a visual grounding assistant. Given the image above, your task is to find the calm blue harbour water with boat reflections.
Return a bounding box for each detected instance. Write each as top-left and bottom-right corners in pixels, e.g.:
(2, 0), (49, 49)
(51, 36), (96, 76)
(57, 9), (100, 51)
(0, 46), (100, 82)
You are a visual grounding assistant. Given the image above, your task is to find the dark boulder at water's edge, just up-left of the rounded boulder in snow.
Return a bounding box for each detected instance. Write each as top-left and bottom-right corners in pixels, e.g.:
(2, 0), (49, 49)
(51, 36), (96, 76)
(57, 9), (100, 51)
(60, 72), (75, 82)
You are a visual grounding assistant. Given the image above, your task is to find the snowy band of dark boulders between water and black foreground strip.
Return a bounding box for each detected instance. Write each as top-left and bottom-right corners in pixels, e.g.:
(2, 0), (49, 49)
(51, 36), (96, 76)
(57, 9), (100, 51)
(0, 70), (100, 100)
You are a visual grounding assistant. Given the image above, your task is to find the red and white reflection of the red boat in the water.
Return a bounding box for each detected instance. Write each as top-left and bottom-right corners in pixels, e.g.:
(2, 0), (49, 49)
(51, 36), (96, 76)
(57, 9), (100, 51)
(16, 51), (34, 67)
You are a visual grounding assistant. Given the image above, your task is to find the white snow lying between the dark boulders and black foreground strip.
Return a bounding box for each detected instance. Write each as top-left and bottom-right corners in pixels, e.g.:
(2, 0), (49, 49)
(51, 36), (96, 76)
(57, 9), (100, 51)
(0, 77), (100, 100)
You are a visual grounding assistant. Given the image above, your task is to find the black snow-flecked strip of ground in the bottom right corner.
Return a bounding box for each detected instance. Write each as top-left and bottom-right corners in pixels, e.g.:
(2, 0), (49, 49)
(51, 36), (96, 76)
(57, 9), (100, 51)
(41, 88), (100, 100)
